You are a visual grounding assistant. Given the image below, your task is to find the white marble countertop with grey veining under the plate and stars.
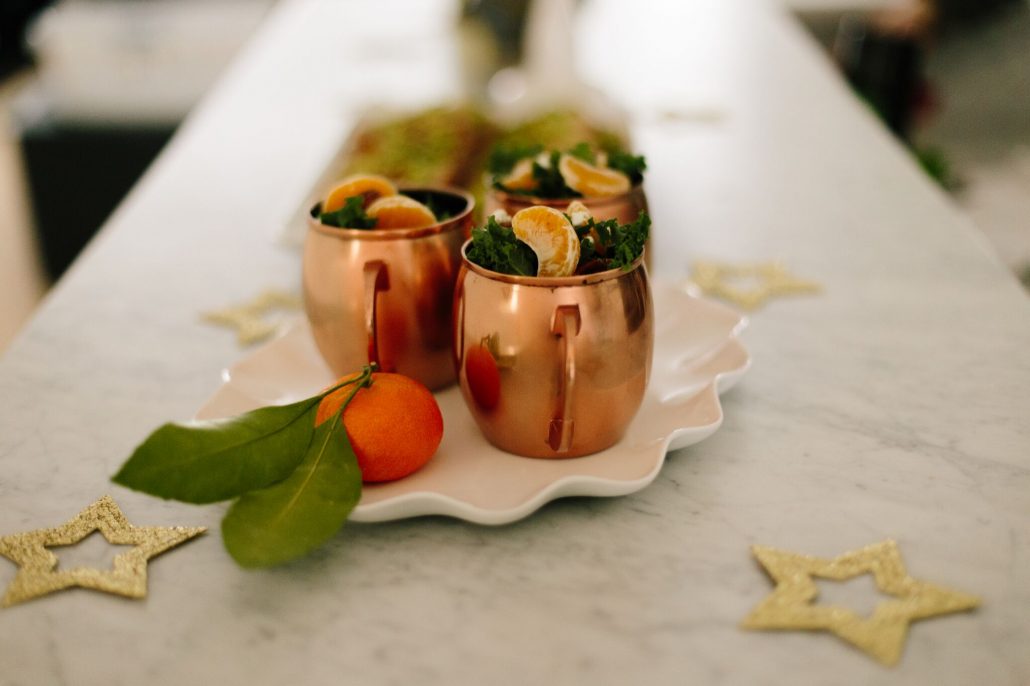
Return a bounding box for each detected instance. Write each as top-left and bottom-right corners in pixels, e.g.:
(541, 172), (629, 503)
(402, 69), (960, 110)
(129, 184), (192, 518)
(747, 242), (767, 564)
(0, 0), (1030, 686)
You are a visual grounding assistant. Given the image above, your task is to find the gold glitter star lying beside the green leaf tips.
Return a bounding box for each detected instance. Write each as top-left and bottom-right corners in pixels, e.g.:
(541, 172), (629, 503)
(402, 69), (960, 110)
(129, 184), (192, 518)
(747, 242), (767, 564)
(0, 495), (206, 608)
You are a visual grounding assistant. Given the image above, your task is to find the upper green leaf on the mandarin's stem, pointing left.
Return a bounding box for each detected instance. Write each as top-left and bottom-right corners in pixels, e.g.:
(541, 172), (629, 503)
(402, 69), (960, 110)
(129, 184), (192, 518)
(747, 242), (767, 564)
(112, 395), (322, 503)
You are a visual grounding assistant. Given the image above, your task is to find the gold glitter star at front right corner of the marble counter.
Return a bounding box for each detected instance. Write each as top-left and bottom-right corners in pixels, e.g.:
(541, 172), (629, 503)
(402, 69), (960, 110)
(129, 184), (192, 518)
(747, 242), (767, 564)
(742, 540), (980, 665)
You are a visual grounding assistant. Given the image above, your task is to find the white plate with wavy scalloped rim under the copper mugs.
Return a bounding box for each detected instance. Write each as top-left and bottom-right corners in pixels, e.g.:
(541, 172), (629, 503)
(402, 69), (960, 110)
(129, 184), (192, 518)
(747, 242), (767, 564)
(197, 281), (751, 524)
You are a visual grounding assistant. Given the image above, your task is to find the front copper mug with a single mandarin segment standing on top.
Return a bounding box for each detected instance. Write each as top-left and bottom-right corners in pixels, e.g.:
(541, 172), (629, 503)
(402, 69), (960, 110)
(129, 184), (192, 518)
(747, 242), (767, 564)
(454, 243), (654, 457)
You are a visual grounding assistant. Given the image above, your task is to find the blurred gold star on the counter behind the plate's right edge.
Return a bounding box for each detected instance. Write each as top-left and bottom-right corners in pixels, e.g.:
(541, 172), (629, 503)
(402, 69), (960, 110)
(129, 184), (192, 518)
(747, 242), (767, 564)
(689, 257), (822, 310)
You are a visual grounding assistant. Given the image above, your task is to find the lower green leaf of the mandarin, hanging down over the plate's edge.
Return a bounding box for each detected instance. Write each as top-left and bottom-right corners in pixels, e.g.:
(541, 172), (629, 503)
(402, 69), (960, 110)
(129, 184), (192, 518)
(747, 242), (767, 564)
(221, 415), (362, 567)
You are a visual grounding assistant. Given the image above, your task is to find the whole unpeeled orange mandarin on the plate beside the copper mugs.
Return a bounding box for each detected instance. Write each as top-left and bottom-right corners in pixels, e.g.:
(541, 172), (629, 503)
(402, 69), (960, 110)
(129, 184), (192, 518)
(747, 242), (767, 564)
(315, 372), (444, 482)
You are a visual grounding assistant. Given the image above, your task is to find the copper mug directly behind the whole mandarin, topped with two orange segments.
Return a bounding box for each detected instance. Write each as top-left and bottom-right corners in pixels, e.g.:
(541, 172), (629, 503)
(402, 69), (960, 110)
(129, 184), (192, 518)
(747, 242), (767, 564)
(303, 188), (475, 389)
